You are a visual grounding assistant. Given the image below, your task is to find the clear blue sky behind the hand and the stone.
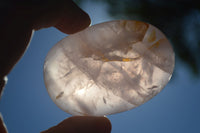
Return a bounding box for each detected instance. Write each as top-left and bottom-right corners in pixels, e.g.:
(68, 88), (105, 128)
(0, 1), (200, 133)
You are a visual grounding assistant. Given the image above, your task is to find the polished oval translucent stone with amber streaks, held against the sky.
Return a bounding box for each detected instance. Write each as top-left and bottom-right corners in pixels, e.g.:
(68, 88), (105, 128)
(44, 20), (175, 116)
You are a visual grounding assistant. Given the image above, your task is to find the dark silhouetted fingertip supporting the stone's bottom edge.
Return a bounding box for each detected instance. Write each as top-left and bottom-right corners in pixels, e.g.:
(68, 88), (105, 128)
(42, 116), (111, 133)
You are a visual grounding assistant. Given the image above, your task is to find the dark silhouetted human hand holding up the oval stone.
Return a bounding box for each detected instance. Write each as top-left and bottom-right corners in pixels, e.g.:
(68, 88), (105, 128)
(0, 0), (111, 133)
